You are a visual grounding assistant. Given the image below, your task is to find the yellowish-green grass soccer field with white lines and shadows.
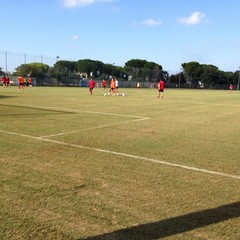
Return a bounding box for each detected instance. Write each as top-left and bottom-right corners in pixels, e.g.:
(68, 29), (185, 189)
(0, 87), (240, 240)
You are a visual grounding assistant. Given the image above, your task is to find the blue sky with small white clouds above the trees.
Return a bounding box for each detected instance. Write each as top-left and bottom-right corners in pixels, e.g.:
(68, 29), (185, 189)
(0, 0), (240, 73)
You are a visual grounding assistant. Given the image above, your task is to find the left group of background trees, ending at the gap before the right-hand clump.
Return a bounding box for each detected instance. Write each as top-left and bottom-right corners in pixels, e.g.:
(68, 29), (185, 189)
(12, 59), (166, 81)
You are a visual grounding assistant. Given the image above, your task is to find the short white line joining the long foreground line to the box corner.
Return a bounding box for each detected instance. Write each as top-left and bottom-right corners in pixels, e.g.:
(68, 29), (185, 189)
(39, 118), (149, 138)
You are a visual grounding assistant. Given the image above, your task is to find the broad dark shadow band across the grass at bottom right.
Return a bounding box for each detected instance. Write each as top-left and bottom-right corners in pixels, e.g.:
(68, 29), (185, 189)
(79, 202), (240, 240)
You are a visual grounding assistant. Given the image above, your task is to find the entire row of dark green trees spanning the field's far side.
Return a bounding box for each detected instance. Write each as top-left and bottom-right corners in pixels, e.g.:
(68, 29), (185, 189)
(0, 59), (240, 89)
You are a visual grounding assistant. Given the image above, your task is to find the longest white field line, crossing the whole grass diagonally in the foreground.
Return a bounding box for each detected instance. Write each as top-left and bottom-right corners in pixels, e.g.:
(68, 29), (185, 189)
(0, 130), (240, 180)
